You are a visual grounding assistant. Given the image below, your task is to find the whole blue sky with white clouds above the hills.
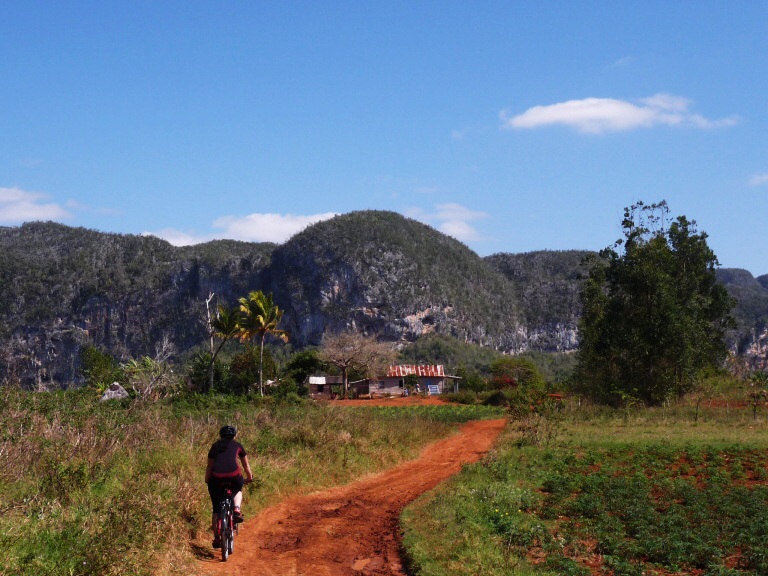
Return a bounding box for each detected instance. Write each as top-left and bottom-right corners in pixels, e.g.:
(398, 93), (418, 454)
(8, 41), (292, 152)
(0, 0), (768, 275)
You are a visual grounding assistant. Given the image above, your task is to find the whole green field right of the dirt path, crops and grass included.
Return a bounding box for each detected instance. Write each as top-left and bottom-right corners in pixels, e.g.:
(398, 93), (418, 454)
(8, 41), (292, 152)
(402, 405), (768, 576)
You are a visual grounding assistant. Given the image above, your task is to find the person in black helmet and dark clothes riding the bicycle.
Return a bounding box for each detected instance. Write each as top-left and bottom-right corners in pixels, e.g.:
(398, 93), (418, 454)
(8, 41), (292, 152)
(205, 426), (253, 548)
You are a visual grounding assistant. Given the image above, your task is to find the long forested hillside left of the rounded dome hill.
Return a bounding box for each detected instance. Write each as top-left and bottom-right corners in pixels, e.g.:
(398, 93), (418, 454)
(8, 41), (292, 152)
(0, 223), (274, 384)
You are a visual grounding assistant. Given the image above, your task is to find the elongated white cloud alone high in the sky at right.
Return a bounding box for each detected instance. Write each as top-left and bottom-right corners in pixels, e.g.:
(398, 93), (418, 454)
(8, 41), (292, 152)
(500, 94), (738, 134)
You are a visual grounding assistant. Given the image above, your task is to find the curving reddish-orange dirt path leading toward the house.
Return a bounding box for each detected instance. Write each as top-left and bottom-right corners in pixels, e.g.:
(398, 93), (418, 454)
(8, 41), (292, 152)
(204, 418), (507, 576)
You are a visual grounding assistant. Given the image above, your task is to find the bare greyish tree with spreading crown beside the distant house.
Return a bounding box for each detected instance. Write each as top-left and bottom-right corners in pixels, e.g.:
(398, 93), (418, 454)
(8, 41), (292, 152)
(319, 332), (395, 396)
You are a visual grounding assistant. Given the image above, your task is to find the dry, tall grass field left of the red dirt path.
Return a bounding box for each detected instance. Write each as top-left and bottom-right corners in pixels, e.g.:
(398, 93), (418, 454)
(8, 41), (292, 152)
(0, 388), (499, 576)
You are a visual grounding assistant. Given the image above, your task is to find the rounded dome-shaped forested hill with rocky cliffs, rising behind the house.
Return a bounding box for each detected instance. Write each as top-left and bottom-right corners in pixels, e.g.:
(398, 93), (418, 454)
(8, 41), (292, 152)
(270, 211), (526, 350)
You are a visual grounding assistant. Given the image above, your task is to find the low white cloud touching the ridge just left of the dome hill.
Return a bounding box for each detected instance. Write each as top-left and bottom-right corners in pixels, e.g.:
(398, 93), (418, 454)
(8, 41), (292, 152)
(145, 212), (336, 246)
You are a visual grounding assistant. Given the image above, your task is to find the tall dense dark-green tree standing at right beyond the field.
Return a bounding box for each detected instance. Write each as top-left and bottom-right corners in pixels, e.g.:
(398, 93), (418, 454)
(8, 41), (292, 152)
(574, 201), (733, 405)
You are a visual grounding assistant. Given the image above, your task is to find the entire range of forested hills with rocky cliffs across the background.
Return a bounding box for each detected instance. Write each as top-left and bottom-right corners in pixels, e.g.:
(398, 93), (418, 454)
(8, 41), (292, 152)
(0, 211), (768, 385)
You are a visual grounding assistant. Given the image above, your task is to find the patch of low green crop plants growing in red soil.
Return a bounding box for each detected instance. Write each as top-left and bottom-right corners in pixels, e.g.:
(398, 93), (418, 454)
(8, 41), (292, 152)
(538, 445), (768, 573)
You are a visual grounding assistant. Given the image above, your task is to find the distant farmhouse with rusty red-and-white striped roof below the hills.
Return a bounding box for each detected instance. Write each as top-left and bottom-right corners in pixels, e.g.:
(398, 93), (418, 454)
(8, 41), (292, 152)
(351, 364), (461, 396)
